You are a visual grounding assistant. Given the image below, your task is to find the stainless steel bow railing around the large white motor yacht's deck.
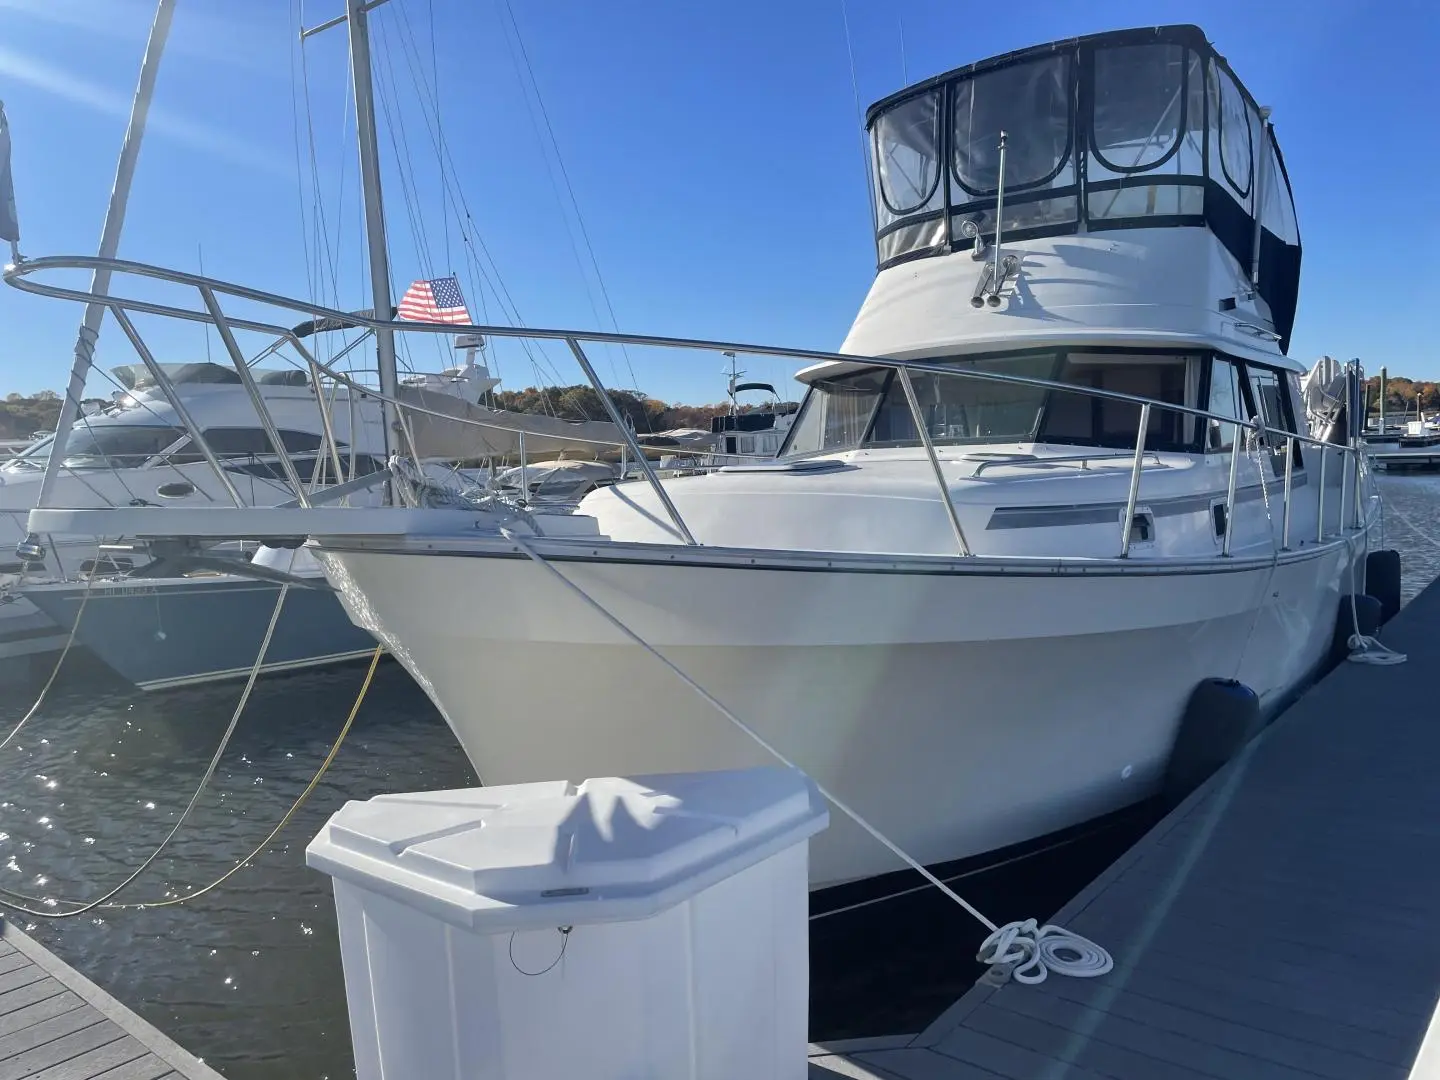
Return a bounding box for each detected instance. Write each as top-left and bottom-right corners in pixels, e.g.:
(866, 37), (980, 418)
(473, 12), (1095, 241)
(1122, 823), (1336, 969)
(4, 256), (1368, 559)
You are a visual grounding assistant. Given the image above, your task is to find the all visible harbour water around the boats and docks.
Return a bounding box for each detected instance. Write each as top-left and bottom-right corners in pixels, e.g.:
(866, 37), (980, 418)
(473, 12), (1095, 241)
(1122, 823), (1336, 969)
(0, 475), (1440, 1080)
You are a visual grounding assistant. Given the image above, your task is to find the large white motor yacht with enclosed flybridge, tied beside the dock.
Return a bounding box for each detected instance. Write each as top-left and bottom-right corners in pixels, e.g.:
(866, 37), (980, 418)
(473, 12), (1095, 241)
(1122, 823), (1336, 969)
(14, 26), (1377, 887)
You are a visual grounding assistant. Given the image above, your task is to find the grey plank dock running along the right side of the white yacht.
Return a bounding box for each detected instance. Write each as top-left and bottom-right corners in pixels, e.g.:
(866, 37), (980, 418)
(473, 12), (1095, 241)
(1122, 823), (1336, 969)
(809, 585), (1440, 1080)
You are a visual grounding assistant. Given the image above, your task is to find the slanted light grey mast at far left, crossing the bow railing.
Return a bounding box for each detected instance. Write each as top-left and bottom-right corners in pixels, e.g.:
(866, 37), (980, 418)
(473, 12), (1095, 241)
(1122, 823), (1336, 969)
(36, 0), (174, 507)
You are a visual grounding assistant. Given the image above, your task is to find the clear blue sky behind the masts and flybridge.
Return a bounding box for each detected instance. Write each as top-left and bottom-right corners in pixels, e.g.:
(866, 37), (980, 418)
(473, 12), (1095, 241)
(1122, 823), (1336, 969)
(0, 0), (1440, 402)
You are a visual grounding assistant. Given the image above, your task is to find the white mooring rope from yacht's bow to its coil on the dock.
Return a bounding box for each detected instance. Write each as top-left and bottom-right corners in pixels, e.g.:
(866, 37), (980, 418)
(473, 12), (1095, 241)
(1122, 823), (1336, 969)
(500, 528), (1115, 982)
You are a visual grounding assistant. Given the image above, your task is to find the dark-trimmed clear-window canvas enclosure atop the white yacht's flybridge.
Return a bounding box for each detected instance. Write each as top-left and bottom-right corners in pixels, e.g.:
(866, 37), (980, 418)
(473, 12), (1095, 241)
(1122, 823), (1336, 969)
(865, 26), (1300, 350)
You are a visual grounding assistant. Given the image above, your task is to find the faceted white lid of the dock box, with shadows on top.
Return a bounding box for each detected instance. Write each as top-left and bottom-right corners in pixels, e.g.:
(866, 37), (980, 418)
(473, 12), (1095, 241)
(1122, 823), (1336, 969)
(305, 768), (828, 933)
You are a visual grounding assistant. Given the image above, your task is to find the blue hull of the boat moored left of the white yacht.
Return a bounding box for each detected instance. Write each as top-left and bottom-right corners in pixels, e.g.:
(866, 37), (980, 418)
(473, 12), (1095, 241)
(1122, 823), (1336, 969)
(26, 576), (376, 690)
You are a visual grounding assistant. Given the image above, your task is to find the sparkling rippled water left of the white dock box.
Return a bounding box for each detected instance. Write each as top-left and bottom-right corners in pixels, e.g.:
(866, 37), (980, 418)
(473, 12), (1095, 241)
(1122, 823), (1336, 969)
(0, 660), (475, 1080)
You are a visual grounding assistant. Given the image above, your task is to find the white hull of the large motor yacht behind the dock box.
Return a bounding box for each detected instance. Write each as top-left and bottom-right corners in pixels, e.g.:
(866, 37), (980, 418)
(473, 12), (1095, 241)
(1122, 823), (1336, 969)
(318, 541), (1351, 887)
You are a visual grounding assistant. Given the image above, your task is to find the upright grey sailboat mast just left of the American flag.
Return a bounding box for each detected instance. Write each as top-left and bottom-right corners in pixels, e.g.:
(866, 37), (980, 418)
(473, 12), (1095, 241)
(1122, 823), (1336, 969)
(346, 0), (397, 478)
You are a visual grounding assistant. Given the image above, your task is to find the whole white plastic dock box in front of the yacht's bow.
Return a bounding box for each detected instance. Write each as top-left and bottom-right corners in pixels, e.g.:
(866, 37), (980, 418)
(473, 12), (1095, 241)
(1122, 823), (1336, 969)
(305, 768), (828, 1080)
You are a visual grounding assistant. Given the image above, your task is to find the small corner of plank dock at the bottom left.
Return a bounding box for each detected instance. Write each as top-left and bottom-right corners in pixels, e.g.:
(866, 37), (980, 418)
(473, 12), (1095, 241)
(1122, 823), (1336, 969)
(0, 922), (223, 1080)
